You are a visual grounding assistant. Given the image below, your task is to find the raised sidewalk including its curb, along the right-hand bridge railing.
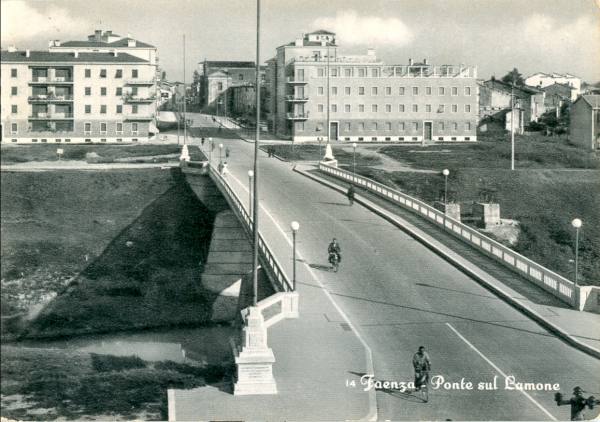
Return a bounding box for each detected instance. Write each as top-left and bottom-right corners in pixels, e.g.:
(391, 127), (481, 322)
(296, 166), (600, 358)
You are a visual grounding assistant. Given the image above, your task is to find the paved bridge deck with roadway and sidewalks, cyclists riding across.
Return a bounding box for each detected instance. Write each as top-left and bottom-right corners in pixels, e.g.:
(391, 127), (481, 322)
(169, 113), (600, 420)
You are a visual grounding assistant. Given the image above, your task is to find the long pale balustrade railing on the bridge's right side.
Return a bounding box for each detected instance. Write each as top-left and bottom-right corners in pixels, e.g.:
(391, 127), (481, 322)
(319, 163), (583, 309)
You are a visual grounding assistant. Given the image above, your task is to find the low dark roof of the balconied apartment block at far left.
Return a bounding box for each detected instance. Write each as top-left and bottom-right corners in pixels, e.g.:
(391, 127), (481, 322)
(0, 51), (148, 63)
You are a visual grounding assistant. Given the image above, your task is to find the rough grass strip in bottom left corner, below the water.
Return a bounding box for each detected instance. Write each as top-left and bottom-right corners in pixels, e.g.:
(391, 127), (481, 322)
(1, 346), (233, 420)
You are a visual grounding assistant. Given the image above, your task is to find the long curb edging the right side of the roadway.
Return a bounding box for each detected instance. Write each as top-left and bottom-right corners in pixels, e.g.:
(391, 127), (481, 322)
(293, 167), (600, 359)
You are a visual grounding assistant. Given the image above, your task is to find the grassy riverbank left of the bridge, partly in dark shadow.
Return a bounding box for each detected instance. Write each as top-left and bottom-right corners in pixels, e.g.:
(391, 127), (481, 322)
(2, 169), (214, 336)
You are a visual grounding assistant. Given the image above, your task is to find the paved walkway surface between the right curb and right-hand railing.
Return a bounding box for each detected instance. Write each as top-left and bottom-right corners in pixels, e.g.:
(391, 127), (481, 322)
(298, 166), (600, 351)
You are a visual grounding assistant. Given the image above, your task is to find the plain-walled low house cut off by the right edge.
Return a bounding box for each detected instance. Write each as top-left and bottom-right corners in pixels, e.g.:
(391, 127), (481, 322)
(569, 95), (600, 150)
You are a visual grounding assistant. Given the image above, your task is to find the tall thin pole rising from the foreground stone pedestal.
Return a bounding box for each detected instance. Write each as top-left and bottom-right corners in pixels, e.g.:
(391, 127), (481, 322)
(252, 0), (260, 306)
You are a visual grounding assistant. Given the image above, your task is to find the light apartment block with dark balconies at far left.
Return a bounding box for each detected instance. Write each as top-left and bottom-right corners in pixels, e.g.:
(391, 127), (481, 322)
(1, 49), (156, 143)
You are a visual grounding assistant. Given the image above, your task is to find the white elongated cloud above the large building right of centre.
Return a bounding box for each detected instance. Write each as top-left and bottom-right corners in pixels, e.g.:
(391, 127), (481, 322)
(312, 10), (414, 47)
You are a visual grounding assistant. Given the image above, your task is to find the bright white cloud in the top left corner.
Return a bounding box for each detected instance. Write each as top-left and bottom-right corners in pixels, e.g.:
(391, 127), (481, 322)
(1, 0), (90, 44)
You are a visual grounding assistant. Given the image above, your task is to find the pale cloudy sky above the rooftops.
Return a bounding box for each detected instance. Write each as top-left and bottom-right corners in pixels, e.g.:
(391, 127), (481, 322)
(1, 0), (600, 82)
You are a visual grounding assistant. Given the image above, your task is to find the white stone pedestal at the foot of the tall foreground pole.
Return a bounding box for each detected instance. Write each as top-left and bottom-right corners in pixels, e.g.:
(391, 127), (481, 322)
(233, 307), (277, 396)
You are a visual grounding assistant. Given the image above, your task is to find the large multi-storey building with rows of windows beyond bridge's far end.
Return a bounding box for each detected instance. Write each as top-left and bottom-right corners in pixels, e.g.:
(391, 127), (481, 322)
(267, 30), (479, 142)
